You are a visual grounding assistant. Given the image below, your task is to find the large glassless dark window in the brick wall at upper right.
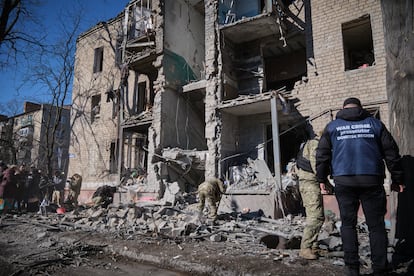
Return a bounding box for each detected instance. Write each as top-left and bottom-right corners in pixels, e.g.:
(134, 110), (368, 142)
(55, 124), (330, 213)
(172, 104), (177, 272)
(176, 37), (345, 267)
(342, 15), (375, 71)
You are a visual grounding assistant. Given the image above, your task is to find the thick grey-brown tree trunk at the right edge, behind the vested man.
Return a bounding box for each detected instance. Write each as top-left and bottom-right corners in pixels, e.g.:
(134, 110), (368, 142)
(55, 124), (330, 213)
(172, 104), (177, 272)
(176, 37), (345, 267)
(381, 0), (414, 156)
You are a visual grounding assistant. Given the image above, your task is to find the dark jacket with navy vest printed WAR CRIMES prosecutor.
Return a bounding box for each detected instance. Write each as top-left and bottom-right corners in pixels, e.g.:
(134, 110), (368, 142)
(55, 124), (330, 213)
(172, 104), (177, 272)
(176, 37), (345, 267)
(316, 107), (402, 186)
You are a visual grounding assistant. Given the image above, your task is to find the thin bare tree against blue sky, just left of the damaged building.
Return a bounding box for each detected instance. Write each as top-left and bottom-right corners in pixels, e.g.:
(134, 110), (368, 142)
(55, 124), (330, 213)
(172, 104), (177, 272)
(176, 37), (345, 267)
(26, 10), (81, 176)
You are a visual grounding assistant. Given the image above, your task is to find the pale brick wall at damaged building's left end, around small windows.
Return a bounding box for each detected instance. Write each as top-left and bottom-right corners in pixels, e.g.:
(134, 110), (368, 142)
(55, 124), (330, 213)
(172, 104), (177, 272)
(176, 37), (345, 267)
(68, 19), (122, 189)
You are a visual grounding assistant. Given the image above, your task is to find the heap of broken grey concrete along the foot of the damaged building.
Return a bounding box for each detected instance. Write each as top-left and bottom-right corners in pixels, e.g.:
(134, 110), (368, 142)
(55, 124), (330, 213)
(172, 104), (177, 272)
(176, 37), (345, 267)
(43, 198), (369, 265)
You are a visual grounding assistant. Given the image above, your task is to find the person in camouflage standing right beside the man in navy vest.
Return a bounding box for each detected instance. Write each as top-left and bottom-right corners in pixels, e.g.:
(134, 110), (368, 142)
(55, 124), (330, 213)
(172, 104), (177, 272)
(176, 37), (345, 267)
(296, 137), (325, 260)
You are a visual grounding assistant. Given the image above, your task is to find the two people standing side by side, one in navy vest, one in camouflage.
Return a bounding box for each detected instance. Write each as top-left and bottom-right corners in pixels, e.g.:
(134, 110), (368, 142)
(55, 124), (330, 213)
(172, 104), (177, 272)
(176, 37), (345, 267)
(297, 98), (404, 275)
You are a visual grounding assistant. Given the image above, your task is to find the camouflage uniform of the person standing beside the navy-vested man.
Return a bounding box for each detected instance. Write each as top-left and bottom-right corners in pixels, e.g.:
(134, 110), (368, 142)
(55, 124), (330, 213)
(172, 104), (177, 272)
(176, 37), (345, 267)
(297, 139), (325, 250)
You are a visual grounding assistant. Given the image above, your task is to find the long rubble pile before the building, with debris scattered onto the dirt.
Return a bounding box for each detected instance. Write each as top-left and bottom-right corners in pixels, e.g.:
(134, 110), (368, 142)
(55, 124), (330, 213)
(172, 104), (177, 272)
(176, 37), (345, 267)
(3, 201), (410, 270)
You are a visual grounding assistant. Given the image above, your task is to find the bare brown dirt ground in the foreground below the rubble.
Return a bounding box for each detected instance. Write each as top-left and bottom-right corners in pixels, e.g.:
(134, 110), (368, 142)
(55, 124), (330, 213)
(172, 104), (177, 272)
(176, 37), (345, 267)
(0, 214), (408, 276)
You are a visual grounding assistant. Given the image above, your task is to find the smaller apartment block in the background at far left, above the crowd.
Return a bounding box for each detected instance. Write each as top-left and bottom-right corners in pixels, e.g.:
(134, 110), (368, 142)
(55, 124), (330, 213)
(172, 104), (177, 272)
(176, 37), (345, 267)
(0, 102), (70, 175)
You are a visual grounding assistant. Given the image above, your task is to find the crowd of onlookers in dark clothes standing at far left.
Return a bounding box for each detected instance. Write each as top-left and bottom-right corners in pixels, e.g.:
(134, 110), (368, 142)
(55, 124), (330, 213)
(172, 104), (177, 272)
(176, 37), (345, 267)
(0, 162), (65, 214)
